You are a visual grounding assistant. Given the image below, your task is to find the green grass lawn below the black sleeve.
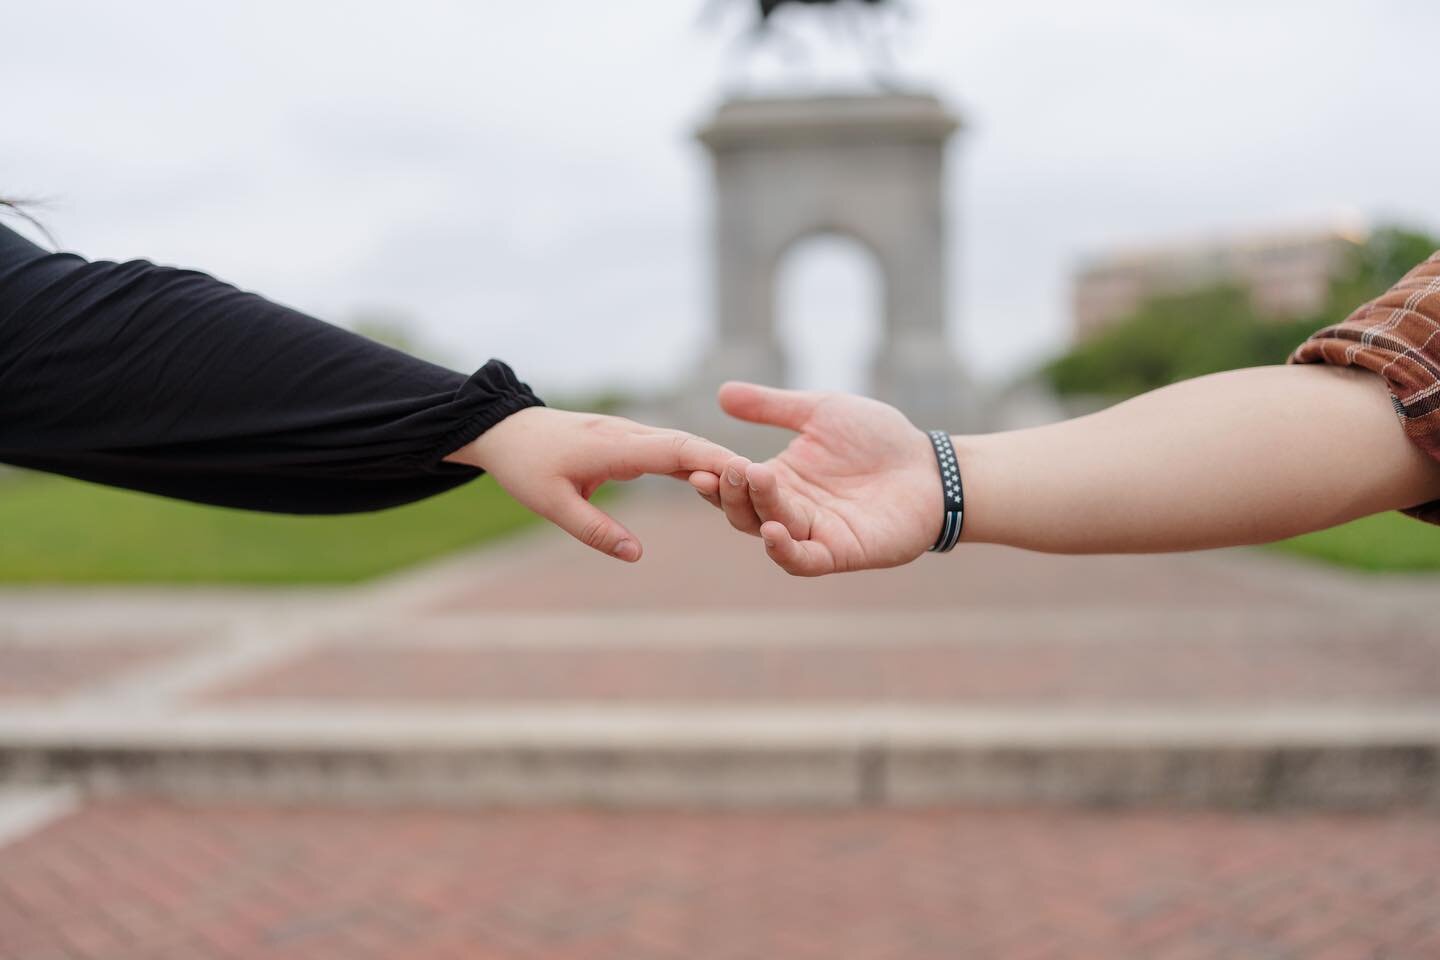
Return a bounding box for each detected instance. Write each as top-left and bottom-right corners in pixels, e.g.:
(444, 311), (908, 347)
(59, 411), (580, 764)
(0, 475), (536, 584)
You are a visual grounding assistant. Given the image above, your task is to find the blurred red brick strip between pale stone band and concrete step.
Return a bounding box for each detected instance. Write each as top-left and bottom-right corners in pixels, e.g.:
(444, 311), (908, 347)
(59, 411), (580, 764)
(215, 630), (1440, 705)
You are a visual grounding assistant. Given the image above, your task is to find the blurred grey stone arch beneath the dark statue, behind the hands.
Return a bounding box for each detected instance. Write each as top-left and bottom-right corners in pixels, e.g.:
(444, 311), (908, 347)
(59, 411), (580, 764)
(691, 94), (968, 430)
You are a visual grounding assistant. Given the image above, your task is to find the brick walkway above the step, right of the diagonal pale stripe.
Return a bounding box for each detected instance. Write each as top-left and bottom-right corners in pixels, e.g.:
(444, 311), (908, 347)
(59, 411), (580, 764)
(194, 498), (1440, 705)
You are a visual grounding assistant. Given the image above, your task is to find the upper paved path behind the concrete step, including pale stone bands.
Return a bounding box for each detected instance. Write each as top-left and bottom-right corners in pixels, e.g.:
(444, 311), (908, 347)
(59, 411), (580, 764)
(0, 497), (1440, 715)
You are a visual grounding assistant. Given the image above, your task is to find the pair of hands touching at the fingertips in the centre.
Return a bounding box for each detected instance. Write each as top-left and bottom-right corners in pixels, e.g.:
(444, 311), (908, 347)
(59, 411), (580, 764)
(446, 383), (943, 577)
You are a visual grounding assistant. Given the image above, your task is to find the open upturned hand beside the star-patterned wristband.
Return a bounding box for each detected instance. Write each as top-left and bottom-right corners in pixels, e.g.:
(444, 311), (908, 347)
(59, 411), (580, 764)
(690, 383), (943, 577)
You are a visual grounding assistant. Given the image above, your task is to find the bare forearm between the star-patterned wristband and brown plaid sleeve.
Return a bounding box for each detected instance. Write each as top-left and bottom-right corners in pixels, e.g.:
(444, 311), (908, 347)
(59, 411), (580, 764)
(955, 366), (1440, 553)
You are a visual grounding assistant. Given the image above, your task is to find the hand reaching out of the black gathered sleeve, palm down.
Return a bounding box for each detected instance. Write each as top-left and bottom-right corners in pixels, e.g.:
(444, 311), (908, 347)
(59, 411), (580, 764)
(445, 407), (734, 563)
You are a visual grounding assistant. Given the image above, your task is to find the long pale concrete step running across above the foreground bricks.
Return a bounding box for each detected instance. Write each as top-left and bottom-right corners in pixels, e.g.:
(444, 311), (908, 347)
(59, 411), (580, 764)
(0, 704), (1440, 809)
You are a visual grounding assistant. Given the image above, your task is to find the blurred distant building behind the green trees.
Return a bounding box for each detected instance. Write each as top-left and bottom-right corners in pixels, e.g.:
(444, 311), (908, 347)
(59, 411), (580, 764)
(1073, 229), (1365, 340)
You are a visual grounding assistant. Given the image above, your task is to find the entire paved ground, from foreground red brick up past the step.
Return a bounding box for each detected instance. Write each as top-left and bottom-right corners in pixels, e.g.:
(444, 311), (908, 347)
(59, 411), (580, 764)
(0, 498), (1440, 960)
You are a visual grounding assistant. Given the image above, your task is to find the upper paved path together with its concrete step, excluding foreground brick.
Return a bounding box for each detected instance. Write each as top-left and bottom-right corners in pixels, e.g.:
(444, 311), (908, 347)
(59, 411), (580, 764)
(0, 495), (1440, 806)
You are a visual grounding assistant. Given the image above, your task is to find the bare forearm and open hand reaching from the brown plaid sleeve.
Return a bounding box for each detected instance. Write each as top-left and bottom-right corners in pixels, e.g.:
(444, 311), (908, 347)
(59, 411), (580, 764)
(693, 366), (1440, 576)
